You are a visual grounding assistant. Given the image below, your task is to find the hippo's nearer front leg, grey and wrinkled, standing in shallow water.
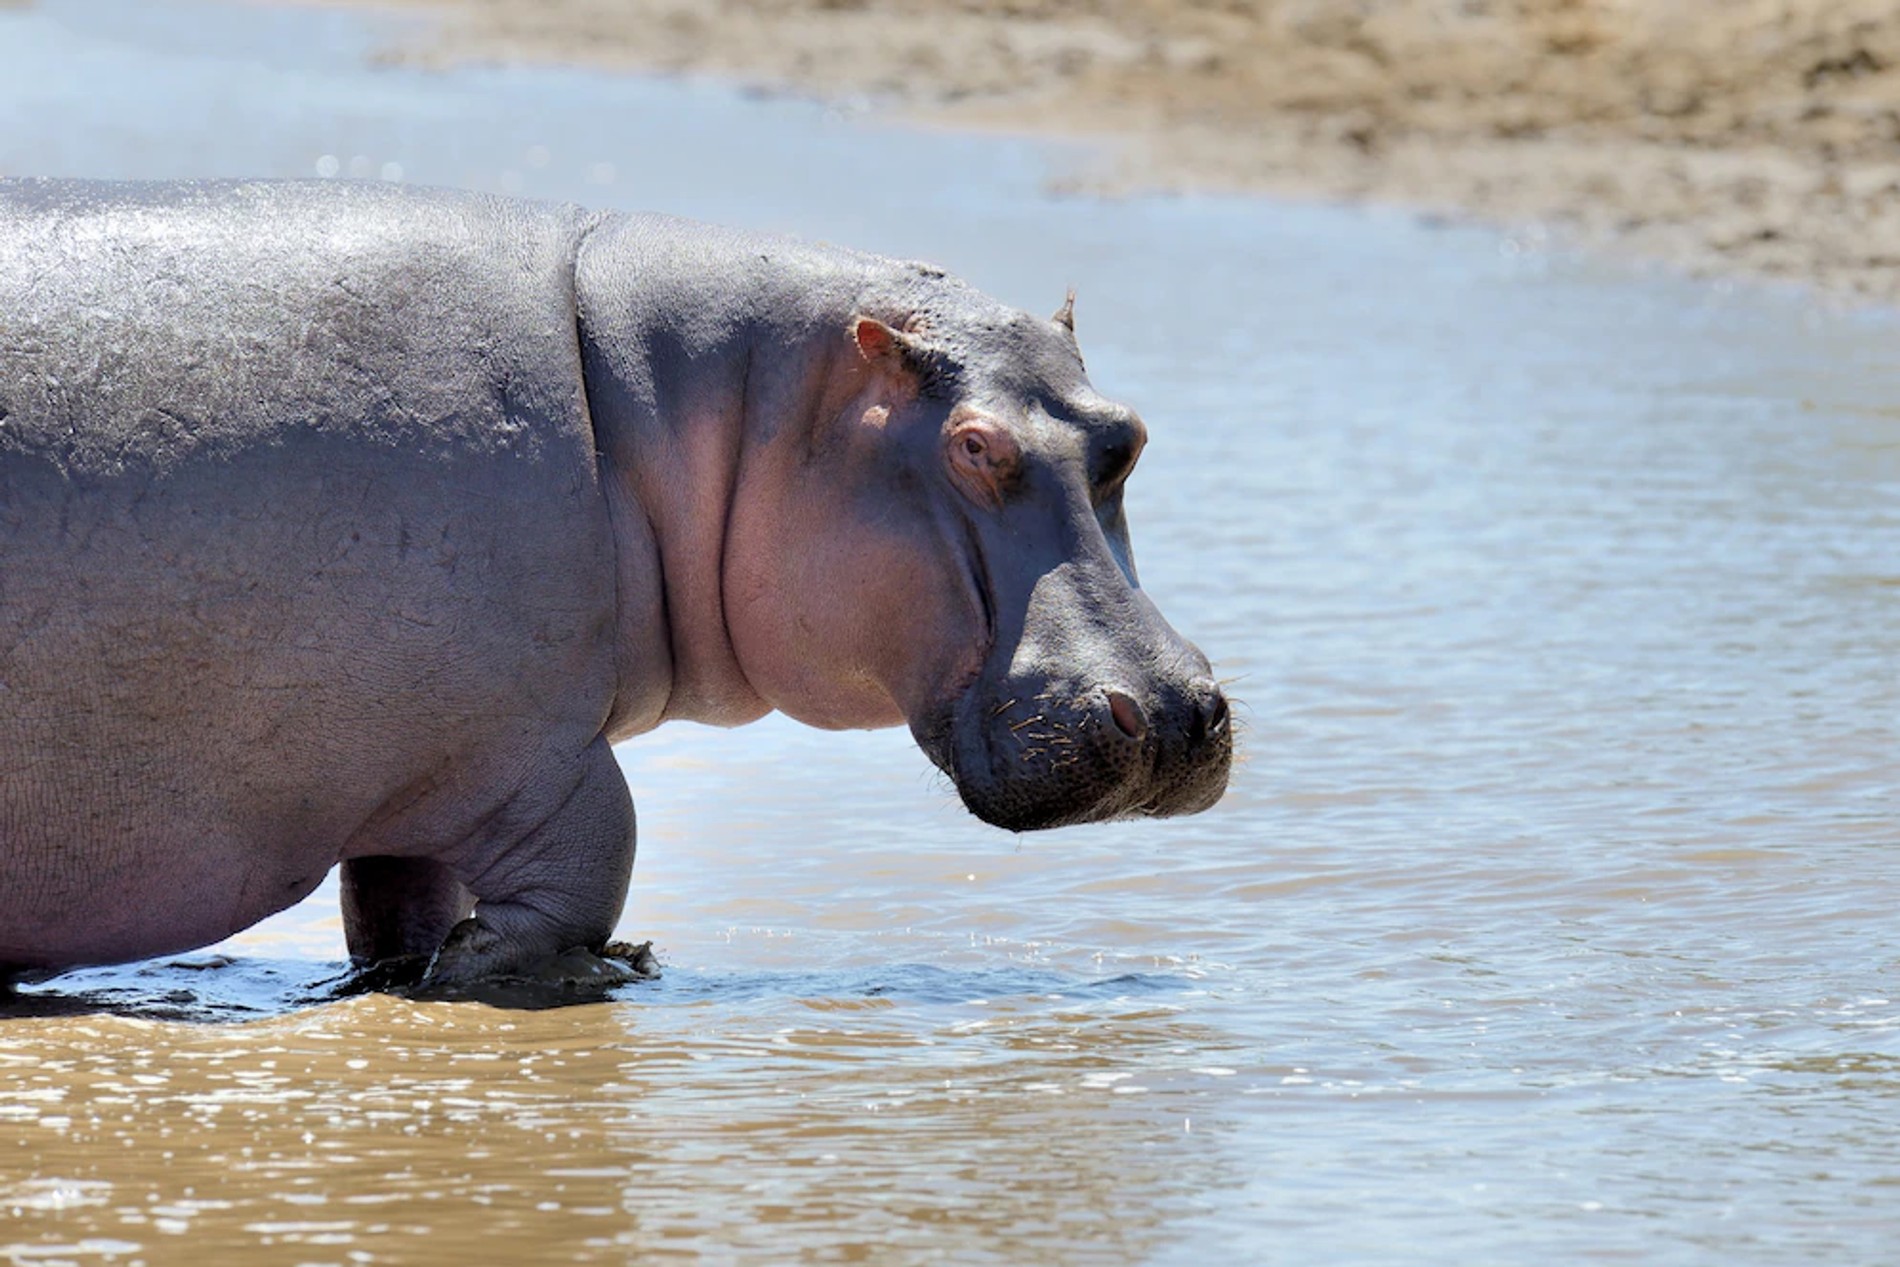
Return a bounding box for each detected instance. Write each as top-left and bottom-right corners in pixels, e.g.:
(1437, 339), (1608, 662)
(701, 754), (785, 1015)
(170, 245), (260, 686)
(422, 737), (646, 995)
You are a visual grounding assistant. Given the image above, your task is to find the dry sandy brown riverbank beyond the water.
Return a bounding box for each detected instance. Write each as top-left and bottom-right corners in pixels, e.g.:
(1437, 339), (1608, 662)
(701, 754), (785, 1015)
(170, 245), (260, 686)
(285, 0), (1900, 300)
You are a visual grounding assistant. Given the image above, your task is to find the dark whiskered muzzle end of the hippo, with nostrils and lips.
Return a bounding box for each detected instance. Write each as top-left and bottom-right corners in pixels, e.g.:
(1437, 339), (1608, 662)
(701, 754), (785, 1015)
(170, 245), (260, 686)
(929, 676), (1233, 832)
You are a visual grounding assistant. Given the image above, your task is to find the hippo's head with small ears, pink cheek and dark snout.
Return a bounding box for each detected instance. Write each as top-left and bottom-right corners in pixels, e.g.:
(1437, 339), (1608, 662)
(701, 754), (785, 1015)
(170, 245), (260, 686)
(728, 274), (1233, 830)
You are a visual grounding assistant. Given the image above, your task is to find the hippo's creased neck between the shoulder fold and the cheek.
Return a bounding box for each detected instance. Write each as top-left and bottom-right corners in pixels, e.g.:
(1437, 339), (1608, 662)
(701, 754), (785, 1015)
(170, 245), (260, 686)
(576, 217), (882, 739)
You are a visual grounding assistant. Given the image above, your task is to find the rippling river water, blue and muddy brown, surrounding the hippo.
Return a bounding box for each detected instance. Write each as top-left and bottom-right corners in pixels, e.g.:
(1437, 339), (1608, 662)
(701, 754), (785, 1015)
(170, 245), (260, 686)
(0, 0), (1900, 1265)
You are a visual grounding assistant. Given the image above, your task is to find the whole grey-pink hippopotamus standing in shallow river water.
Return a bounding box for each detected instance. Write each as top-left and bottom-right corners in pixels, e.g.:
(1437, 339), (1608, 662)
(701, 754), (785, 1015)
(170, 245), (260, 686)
(0, 180), (1233, 992)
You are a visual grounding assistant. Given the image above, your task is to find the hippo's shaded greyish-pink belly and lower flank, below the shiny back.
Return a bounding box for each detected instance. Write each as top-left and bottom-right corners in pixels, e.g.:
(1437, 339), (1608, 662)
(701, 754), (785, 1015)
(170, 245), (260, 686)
(0, 440), (610, 965)
